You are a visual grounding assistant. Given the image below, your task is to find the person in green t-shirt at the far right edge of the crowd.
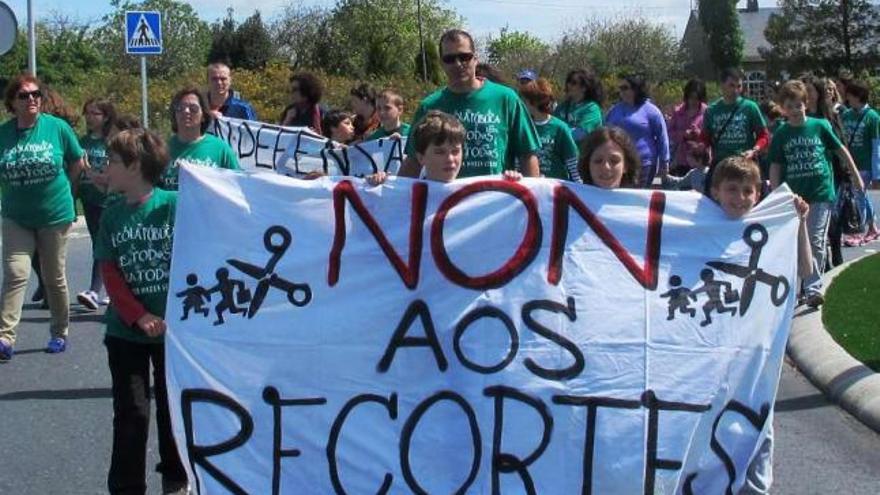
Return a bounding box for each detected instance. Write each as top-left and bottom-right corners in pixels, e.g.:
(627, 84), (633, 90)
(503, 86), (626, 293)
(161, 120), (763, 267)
(842, 81), (880, 244)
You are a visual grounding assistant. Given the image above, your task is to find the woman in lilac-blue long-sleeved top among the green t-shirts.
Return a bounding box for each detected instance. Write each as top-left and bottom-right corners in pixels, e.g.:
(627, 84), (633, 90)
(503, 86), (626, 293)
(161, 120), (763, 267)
(605, 75), (669, 187)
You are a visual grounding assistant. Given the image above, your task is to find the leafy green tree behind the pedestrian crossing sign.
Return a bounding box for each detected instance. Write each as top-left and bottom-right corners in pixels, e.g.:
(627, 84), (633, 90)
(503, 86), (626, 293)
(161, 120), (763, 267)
(95, 0), (211, 76)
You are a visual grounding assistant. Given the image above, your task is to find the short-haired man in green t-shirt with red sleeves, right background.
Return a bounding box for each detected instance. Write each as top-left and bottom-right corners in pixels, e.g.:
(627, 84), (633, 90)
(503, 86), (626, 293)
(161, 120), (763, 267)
(703, 68), (770, 179)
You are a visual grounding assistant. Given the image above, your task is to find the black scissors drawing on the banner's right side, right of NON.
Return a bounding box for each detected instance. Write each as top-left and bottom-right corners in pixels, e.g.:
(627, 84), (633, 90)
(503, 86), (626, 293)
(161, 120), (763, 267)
(706, 223), (791, 316)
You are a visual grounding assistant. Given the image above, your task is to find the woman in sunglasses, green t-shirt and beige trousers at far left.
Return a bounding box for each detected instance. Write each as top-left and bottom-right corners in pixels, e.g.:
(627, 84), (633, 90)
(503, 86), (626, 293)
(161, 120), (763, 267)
(0, 75), (85, 361)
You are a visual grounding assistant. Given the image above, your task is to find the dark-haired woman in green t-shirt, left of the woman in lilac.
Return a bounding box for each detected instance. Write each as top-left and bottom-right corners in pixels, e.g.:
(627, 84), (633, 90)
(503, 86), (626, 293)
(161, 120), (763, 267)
(553, 69), (605, 143)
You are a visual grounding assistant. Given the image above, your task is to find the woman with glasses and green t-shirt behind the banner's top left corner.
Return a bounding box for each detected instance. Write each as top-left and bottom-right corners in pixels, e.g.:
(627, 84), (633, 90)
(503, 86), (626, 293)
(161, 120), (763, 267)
(159, 87), (240, 191)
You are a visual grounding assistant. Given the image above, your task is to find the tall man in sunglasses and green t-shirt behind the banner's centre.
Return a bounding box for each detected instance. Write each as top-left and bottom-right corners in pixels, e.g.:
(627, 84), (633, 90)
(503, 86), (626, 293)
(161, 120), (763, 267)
(400, 29), (541, 177)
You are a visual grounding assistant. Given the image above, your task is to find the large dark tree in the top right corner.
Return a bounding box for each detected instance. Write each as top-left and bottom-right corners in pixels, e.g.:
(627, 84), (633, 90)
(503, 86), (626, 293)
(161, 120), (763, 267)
(759, 0), (880, 74)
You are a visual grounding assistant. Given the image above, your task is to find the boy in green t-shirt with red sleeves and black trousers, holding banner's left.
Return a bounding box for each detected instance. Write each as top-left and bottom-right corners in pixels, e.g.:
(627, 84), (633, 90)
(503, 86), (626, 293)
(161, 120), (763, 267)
(95, 129), (188, 493)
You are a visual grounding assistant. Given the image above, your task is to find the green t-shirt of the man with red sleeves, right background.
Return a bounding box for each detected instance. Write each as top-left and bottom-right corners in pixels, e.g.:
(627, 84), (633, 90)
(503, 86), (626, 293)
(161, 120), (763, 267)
(703, 97), (767, 163)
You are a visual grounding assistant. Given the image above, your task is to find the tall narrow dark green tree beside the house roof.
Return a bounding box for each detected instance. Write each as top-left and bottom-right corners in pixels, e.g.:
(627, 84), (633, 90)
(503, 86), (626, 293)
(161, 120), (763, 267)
(698, 0), (743, 70)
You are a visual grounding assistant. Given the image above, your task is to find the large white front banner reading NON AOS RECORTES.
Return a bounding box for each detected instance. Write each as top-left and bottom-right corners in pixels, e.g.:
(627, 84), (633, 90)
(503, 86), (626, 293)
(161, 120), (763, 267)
(166, 166), (798, 495)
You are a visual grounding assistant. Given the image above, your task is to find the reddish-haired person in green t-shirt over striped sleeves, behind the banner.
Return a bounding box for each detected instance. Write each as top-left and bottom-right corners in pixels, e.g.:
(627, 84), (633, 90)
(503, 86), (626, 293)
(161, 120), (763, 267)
(519, 78), (581, 182)
